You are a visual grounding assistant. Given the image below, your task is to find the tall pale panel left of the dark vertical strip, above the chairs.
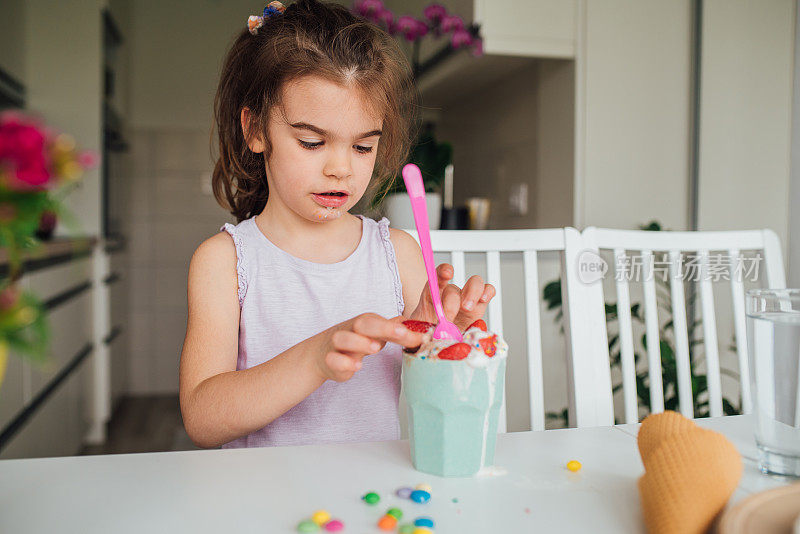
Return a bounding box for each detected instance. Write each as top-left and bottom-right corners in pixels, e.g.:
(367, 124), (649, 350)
(575, 0), (692, 230)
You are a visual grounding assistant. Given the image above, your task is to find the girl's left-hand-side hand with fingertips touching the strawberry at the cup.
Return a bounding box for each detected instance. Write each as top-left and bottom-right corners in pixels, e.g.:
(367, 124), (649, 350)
(318, 313), (425, 382)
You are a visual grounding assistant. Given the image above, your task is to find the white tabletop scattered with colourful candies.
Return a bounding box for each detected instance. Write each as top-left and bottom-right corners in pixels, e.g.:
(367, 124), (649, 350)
(0, 416), (787, 534)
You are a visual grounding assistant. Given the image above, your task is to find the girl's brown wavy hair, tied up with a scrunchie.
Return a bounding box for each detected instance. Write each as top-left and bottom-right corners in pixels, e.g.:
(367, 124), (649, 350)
(211, 0), (419, 221)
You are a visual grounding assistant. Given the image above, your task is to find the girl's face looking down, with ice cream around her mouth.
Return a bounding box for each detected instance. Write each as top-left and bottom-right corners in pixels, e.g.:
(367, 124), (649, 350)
(253, 76), (383, 222)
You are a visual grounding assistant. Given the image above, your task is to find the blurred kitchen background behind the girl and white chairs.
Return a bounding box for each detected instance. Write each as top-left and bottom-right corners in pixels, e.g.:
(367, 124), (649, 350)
(0, 0), (800, 458)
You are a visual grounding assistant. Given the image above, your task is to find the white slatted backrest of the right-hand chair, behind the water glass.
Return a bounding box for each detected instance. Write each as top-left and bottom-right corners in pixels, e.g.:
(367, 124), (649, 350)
(566, 227), (786, 426)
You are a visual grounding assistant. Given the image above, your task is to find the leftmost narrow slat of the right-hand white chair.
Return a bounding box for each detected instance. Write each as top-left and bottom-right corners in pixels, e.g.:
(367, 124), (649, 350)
(614, 248), (639, 423)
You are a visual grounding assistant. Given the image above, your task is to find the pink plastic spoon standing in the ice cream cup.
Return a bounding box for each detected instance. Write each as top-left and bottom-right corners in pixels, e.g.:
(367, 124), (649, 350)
(403, 163), (463, 341)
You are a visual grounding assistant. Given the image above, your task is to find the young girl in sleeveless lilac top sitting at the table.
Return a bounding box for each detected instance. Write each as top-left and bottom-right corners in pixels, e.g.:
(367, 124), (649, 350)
(180, 0), (494, 447)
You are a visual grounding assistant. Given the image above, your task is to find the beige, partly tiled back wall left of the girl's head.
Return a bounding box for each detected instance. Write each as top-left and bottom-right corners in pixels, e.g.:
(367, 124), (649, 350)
(121, 0), (256, 394)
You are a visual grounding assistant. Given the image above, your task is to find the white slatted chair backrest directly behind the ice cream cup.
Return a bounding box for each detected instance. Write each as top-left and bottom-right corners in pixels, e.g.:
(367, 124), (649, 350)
(409, 228), (578, 432)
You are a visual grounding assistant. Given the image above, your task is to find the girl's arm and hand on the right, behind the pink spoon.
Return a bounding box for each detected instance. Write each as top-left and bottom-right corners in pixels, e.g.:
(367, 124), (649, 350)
(389, 228), (495, 330)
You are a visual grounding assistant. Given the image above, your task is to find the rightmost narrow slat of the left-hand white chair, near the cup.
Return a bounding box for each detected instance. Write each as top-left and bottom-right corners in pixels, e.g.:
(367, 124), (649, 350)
(522, 250), (545, 430)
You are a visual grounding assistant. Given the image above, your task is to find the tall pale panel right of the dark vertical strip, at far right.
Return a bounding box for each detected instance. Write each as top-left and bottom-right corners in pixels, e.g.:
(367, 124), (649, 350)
(698, 0), (795, 250)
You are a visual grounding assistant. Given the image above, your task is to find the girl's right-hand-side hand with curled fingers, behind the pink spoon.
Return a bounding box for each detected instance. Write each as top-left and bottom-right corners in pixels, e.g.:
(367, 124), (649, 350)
(411, 263), (496, 331)
